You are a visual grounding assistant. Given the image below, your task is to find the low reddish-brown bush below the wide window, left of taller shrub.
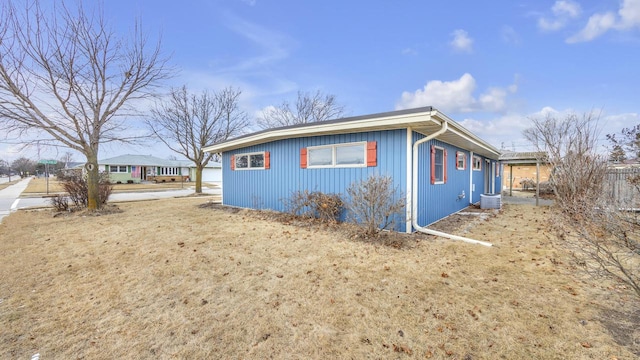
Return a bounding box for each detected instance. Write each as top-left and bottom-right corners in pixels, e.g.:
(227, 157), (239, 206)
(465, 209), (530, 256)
(285, 190), (344, 222)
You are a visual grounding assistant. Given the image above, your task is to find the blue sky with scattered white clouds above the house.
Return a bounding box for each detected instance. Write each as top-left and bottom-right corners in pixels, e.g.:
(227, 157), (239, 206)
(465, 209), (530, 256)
(0, 0), (640, 158)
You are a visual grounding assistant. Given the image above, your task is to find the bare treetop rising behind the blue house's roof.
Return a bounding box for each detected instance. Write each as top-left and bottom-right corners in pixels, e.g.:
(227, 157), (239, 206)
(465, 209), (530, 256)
(257, 91), (345, 129)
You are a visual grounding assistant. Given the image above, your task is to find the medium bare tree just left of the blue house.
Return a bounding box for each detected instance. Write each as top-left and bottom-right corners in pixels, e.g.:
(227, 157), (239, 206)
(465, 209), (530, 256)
(145, 86), (249, 194)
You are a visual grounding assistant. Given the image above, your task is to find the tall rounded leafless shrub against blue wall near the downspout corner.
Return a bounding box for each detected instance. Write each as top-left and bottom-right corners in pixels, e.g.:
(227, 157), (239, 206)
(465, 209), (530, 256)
(346, 175), (405, 237)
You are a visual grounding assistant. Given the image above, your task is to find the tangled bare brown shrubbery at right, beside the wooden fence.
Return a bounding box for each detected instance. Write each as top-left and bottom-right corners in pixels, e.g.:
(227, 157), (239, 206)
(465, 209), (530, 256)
(524, 113), (640, 296)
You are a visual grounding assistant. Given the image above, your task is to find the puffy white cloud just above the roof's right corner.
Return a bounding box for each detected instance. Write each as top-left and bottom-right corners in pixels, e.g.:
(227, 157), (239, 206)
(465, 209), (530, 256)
(396, 73), (518, 113)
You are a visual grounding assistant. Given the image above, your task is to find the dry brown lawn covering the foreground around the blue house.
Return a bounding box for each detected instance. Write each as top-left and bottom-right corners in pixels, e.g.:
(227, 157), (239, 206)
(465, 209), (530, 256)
(0, 198), (640, 359)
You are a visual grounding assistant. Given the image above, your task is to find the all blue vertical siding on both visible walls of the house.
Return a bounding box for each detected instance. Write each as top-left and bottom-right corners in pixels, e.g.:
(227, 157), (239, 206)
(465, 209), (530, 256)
(222, 129), (501, 231)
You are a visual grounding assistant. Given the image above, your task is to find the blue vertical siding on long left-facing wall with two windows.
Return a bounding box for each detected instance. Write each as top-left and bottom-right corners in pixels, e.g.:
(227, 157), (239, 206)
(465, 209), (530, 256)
(222, 130), (407, 231)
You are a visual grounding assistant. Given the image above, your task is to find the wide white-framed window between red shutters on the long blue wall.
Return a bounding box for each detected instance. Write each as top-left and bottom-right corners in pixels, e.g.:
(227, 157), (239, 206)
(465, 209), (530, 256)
(307, 142), (367, 168)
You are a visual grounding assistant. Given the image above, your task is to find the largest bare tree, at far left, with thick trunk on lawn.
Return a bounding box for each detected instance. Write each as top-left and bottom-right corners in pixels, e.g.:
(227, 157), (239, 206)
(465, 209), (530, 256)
(0, 0), (171, 210)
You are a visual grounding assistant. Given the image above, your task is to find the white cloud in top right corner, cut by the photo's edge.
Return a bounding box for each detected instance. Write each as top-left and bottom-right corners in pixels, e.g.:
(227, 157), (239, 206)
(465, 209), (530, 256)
(567, 0), (640, 43)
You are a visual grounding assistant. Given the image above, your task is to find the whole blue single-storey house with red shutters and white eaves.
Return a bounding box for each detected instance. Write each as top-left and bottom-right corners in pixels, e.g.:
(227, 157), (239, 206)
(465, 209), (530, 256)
(203, 107), (501, 236)
